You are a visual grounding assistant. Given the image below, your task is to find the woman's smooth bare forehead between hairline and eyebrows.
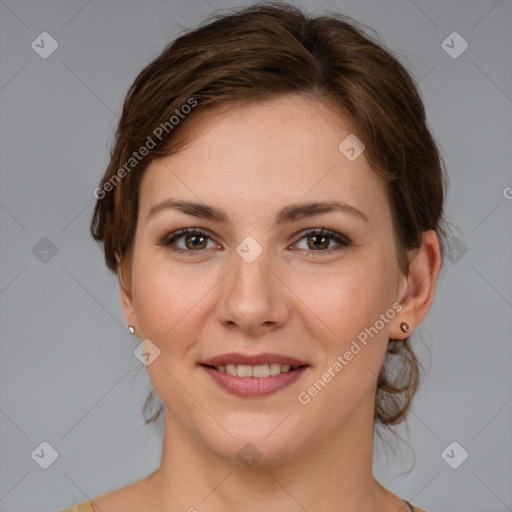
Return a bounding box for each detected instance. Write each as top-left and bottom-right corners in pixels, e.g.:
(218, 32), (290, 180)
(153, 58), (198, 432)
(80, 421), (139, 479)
(136, 96), (387, 224)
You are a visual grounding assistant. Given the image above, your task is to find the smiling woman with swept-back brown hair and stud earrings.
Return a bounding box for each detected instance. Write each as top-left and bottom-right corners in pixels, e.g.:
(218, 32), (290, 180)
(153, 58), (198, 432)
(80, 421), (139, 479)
(59, 4), (445, 512)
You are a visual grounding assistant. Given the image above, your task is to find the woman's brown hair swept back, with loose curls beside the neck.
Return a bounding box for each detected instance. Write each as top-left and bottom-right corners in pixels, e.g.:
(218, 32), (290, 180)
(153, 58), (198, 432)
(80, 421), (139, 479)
(91, 2), (447, 436)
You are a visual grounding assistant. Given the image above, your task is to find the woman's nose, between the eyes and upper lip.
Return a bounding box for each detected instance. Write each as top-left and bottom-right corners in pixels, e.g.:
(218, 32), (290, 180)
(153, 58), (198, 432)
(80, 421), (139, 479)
(217, 247), (291, 336)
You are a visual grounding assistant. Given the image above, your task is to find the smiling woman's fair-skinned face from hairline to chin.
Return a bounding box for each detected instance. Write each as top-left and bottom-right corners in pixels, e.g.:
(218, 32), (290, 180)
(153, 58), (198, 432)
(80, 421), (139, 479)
(122, 96), (405, 463)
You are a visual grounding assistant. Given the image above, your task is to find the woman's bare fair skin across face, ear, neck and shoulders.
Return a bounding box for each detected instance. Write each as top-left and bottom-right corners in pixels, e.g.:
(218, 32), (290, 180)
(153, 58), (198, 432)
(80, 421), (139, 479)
(93, 96), (441, 512)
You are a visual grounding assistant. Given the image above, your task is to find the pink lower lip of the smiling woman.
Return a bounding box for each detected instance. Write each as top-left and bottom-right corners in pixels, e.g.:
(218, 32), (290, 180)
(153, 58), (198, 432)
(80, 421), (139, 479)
(202, 366), (309, 397)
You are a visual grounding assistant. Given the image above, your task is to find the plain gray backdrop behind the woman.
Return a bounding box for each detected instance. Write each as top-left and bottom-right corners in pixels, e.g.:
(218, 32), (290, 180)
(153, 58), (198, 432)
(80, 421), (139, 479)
(0, 0), (512, 512)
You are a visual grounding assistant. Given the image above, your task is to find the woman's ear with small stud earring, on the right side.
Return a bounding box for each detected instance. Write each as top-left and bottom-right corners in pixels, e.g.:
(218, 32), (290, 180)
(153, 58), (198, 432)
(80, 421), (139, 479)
(389, 230), (442, 340)
